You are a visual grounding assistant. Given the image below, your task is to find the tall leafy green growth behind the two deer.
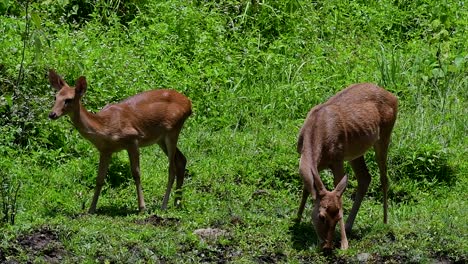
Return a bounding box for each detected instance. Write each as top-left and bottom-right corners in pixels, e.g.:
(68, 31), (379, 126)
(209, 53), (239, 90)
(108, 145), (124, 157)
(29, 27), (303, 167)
(0, 1), (468, 177)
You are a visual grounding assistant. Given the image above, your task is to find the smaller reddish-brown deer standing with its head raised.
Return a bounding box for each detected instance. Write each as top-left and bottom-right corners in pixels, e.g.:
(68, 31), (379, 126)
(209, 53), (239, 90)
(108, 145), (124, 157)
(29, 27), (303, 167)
(49, 70), (192, 213)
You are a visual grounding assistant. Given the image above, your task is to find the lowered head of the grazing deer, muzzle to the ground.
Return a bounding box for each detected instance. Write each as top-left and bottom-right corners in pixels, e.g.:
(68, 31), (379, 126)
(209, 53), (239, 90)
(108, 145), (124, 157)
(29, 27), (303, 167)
(312, 175), (348, 249)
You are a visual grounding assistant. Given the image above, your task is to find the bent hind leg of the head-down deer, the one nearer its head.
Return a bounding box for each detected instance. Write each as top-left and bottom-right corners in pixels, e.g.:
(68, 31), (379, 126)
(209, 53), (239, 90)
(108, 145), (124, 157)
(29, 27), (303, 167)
(346, 156), (371, 233)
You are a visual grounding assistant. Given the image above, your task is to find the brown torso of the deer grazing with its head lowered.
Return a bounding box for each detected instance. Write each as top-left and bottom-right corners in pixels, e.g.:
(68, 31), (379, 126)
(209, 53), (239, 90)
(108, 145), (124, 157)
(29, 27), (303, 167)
(298, 83), (397, 165)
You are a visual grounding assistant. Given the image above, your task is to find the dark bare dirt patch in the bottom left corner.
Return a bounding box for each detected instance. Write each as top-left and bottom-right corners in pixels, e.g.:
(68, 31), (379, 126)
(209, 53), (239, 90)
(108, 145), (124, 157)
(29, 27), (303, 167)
(16, 227), (68, 263)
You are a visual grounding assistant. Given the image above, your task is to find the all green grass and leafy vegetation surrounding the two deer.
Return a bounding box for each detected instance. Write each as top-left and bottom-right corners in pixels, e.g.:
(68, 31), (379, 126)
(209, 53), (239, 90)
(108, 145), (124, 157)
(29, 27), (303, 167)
(0, 0), (468, 263)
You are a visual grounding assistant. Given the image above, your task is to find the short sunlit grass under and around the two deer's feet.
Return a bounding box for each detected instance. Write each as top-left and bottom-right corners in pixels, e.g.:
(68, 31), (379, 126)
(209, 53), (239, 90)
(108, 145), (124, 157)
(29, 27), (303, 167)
(3, 127), (468, 263)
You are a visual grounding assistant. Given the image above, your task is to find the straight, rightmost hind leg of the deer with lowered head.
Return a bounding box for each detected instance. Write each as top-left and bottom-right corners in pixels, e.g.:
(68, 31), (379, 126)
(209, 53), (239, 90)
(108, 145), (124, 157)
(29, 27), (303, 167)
(374, 134), (390, 224)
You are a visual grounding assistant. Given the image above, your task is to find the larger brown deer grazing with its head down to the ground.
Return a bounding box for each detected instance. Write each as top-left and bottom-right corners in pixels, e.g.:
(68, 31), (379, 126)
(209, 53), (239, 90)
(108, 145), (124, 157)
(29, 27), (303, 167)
(297, 83), (398, 249)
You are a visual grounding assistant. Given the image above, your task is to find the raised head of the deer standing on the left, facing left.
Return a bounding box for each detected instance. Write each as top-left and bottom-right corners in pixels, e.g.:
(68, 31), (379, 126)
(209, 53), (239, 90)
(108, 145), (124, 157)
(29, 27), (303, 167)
(49, 70), (87, 119)
